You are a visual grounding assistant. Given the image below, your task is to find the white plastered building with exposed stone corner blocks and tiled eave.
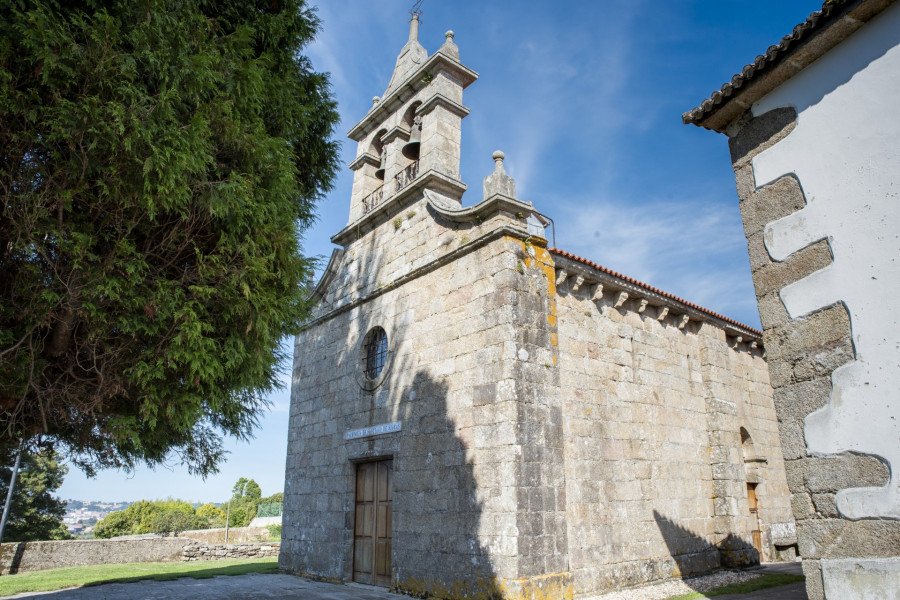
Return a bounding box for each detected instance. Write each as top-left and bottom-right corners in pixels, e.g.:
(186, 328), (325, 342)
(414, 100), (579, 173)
(685, 0), (900, 600)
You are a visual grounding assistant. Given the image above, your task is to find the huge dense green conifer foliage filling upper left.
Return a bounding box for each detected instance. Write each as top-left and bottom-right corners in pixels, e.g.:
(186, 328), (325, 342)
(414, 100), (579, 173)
(0, 0), (337, 475)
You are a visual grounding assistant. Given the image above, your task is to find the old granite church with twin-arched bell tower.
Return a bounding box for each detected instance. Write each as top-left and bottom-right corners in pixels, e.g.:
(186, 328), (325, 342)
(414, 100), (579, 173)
(280, 16), (796, 598)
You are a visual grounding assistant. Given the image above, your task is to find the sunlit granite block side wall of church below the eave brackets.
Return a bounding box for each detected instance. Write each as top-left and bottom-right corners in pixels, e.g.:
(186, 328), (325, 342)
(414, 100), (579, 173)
(558, 278), (794, 591)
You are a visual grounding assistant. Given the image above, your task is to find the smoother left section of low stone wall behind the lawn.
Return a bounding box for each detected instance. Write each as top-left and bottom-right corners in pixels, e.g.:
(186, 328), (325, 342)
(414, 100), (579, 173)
(0, 537), (190, 575)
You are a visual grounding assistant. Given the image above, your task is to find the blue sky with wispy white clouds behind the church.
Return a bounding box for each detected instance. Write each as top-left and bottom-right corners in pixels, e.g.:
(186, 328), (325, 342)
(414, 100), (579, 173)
(59, 0), (821, 501)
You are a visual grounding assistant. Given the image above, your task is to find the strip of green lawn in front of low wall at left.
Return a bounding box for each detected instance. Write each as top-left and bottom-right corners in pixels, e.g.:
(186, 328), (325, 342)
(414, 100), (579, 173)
(0, 558), (278, 596)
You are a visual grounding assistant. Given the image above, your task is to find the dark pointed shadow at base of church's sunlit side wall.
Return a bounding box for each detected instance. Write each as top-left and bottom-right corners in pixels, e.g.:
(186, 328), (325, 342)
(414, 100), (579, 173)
(653, 510), (759, 585)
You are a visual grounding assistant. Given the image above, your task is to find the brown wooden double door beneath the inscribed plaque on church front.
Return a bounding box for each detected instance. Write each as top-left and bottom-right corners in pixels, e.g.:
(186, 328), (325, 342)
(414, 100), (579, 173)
(353, 460), (393, 586)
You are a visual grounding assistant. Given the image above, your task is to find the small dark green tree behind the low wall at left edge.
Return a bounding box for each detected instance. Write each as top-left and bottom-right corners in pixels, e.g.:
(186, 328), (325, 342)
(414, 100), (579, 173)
(0, 448), (71, 542)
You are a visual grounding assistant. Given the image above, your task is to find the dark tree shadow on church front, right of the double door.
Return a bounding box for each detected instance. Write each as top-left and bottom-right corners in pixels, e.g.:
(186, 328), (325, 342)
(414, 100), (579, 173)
(393, 365), (503, 600)
